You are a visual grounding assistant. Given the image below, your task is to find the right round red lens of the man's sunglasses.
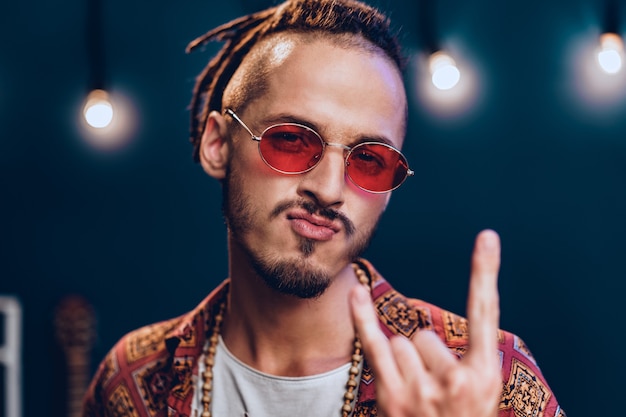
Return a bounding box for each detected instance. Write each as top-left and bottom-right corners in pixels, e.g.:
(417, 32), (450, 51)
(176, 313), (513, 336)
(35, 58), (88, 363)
(346, 143), (409, 193)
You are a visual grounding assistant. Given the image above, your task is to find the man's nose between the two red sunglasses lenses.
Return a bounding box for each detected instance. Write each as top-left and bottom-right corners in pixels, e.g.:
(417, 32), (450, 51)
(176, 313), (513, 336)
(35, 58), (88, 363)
(298, 143), (349, 208)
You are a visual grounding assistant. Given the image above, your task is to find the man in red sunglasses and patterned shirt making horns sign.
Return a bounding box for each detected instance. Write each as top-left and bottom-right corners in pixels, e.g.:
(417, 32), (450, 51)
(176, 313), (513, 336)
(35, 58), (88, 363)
(80, 0), (565, 417)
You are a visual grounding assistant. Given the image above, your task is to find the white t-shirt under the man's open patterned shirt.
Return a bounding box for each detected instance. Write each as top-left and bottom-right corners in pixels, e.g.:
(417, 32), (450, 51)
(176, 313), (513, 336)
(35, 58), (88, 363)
(191, 337), (359, 417)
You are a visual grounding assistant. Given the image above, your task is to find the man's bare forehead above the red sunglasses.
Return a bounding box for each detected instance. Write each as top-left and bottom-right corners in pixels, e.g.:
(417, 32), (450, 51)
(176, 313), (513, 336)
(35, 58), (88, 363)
(241, 34), (407, 147)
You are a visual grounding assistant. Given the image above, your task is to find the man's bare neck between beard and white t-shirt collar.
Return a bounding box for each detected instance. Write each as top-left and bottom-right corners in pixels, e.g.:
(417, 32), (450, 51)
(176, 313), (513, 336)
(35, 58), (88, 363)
(222, 242), (361, 376)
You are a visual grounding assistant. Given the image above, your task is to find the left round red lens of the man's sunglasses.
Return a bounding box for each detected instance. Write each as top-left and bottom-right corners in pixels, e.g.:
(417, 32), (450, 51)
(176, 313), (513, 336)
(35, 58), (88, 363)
(259, 124), (324, 174)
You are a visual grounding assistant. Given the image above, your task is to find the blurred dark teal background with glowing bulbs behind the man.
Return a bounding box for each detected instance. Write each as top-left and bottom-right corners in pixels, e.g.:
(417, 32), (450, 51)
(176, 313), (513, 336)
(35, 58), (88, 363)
(0, 0), (626, 417)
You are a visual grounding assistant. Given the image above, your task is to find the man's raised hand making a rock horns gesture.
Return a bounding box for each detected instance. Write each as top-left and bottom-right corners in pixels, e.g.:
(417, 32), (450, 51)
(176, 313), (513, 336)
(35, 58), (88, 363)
(350, 230), (502, 417)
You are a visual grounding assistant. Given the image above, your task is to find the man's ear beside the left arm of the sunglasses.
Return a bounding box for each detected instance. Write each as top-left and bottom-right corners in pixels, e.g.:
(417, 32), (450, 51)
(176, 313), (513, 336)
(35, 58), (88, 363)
(199, 111), (230, 180)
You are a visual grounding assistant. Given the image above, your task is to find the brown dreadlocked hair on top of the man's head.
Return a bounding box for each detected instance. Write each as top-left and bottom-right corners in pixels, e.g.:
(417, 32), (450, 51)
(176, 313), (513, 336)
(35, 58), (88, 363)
(187, 0), (406, 162)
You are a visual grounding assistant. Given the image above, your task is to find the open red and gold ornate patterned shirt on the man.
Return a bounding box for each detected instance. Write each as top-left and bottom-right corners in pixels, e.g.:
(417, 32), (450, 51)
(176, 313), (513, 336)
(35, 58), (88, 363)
(83, 259), (565, 417)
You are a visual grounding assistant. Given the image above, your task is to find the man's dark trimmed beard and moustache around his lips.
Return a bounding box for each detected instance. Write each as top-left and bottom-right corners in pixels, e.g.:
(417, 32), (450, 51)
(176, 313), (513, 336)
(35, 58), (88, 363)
(222, 167), (378, 299)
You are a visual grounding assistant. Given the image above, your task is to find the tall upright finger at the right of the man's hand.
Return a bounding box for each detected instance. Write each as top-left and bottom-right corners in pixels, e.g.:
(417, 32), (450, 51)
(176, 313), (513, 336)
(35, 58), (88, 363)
(467, 230), (500, 363)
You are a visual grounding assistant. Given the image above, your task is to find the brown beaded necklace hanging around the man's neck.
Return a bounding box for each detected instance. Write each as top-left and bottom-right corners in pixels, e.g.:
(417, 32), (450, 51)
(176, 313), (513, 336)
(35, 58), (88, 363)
(202, 263), (371, 417)
